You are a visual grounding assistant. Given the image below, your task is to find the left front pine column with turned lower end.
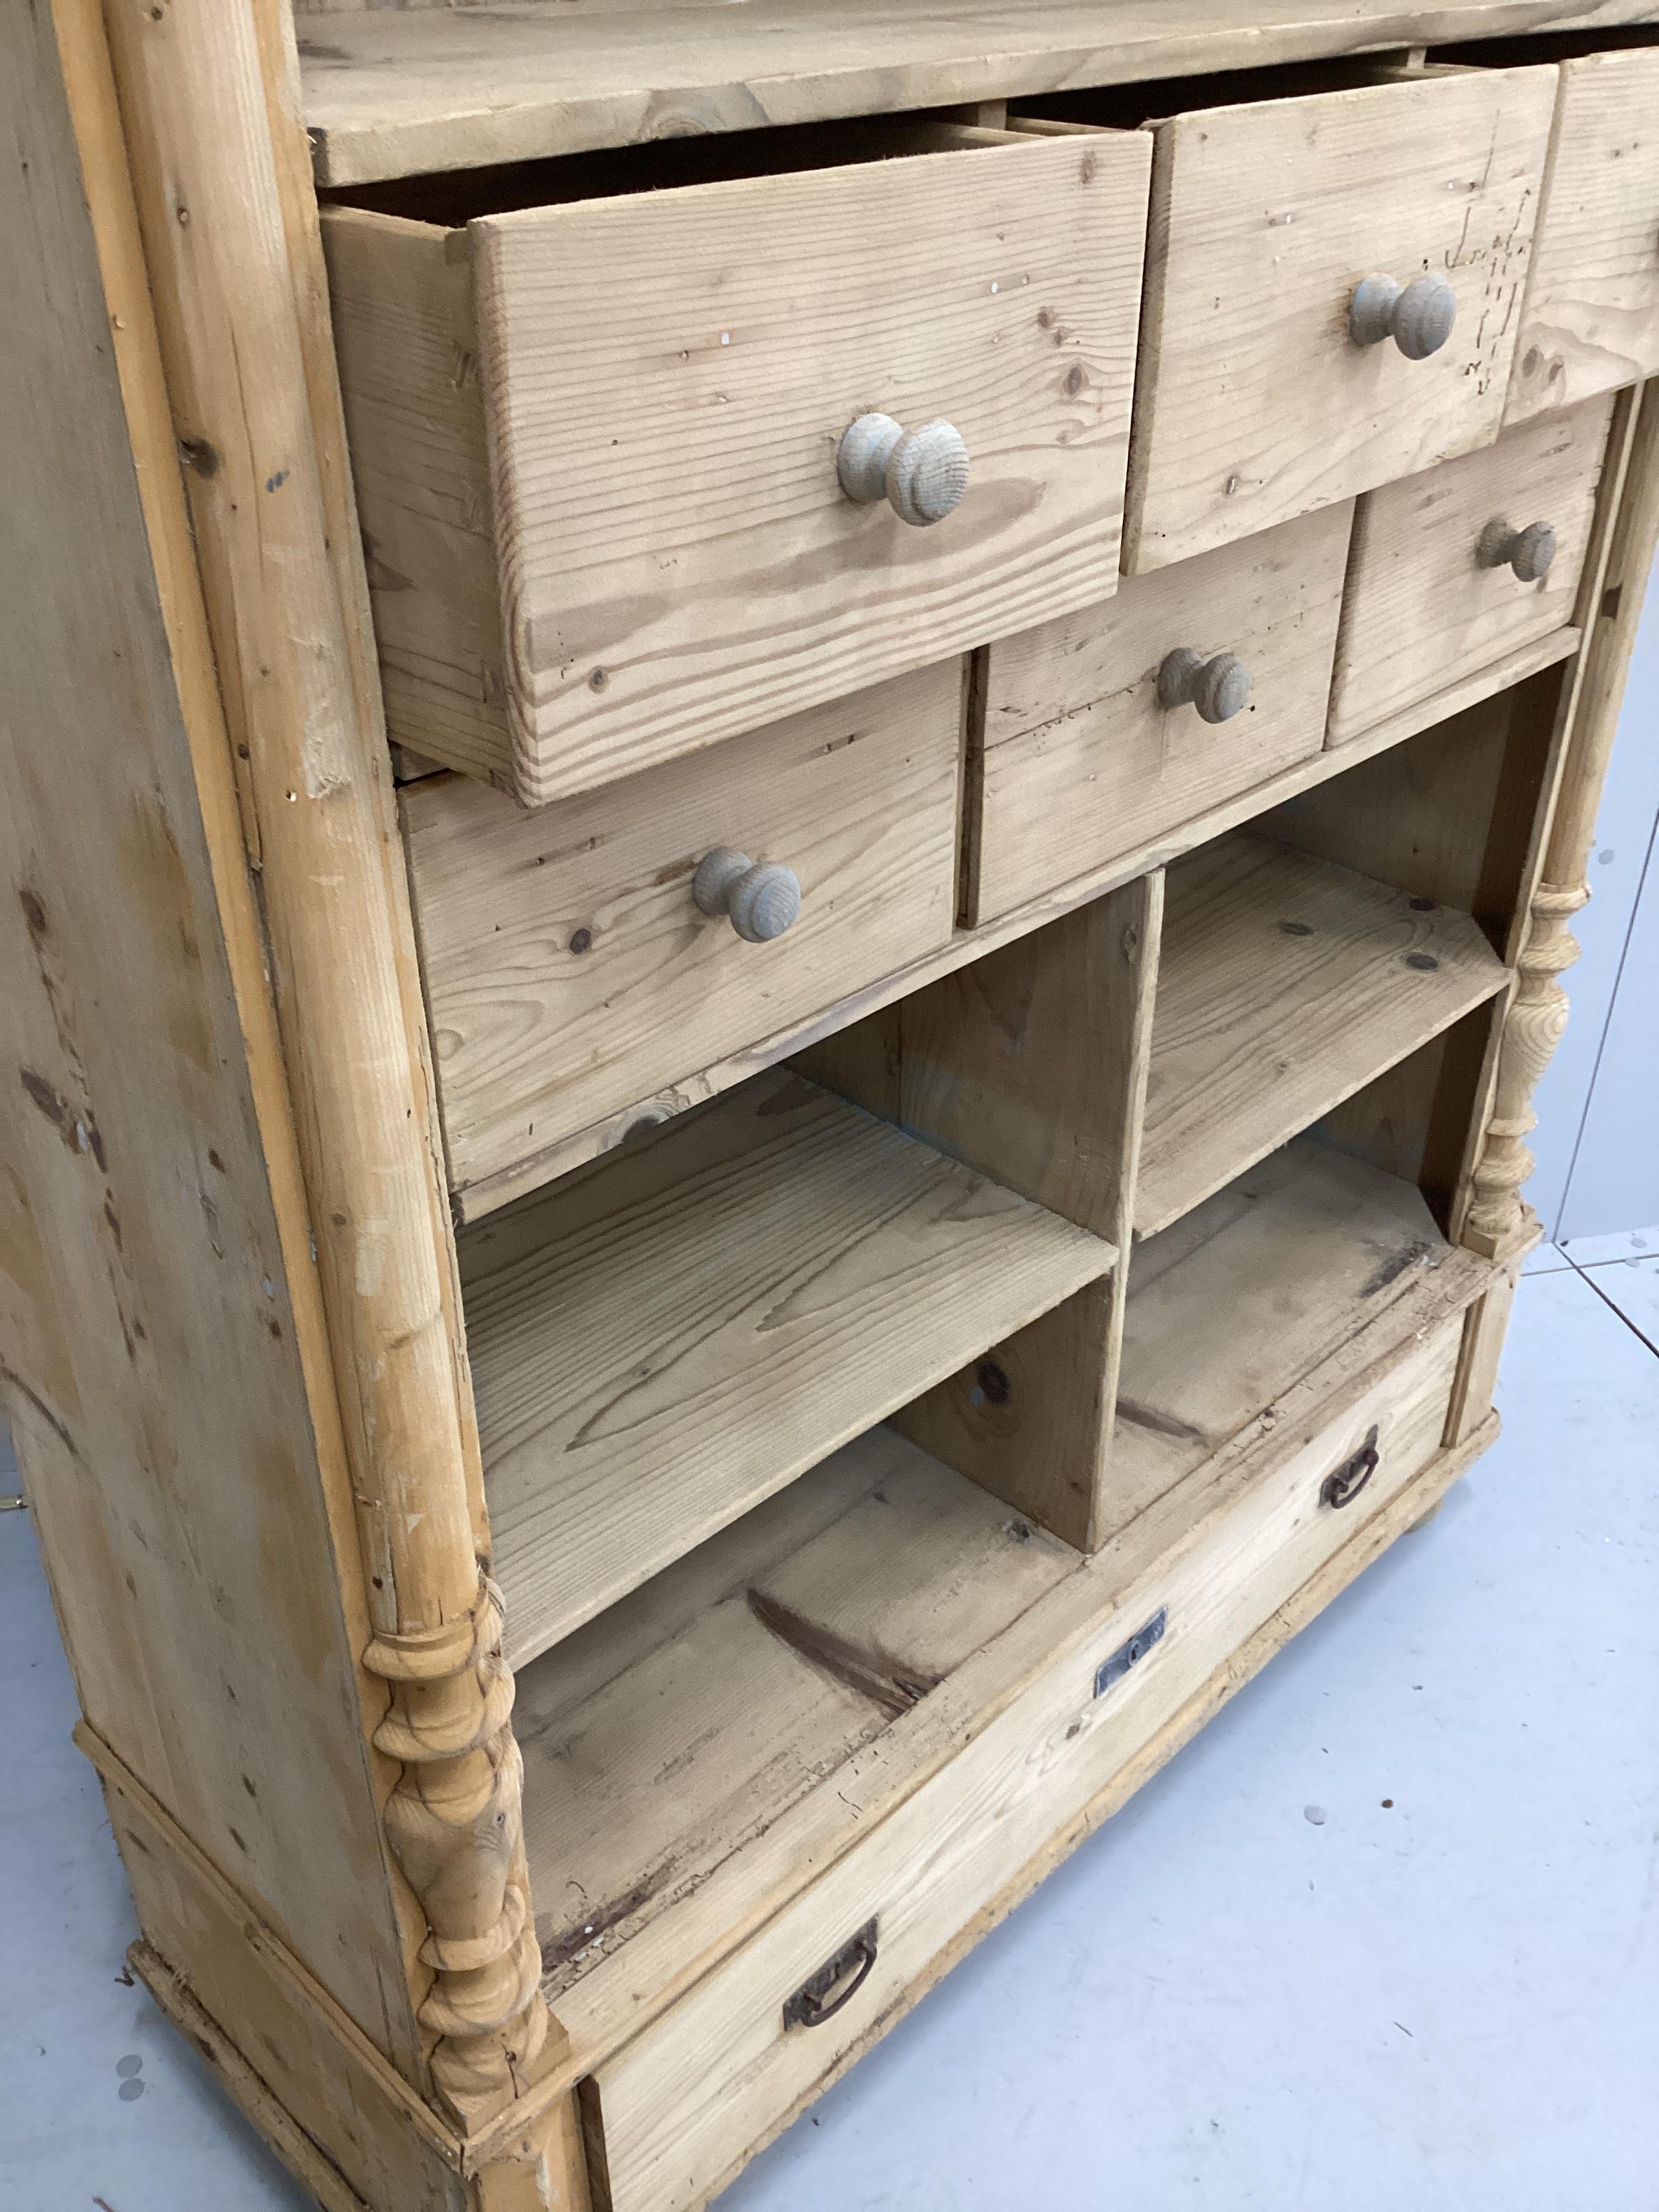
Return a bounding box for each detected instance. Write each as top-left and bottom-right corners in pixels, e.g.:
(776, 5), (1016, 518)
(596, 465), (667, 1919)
(106, 0), (559, 2126)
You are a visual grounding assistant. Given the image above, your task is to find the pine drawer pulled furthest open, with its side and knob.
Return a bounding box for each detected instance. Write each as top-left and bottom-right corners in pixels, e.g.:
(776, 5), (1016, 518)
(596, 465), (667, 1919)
(323, 122), (1150, 805)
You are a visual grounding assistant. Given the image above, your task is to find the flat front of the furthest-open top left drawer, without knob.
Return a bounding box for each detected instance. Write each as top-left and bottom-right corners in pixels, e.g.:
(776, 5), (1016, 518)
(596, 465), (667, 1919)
(473, 140), (1150, 803)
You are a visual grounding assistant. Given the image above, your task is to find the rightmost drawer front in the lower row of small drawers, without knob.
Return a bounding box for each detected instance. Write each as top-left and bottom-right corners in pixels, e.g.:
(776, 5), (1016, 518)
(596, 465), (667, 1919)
(1330, 398), (1612, 743)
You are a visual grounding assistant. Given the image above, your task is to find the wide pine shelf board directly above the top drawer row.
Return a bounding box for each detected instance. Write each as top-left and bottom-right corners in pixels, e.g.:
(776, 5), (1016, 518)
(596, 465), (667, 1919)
(299, 0), (1659, 186)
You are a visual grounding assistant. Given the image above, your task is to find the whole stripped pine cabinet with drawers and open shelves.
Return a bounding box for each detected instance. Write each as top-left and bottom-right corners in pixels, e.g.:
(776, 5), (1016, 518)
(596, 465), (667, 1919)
(13, 13), (1659, 2212)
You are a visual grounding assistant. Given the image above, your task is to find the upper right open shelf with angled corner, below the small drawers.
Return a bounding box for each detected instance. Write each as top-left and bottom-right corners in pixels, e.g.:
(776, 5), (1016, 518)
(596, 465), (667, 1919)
(1134, 832), (1509, 1237)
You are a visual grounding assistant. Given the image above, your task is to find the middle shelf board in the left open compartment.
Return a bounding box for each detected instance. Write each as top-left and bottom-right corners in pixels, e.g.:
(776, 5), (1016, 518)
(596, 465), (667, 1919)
(460, 1073), (1117, 1664)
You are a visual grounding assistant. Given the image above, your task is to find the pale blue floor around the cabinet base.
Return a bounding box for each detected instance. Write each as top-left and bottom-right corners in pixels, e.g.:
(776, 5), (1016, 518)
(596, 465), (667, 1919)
(0, 1265), (1659, 2212)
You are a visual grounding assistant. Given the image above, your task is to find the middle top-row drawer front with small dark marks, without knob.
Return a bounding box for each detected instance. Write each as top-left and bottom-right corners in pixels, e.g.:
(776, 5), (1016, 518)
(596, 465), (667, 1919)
(1124, 68), (1555, 571)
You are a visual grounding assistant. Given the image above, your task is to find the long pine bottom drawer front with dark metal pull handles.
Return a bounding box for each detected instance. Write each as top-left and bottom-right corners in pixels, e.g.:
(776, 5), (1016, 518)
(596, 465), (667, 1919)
(584, 1316), (1495, 2212)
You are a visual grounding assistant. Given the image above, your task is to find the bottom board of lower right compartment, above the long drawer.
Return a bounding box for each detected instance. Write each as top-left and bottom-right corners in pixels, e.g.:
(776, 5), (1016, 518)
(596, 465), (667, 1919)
(1106, 1137), (1453, 1531)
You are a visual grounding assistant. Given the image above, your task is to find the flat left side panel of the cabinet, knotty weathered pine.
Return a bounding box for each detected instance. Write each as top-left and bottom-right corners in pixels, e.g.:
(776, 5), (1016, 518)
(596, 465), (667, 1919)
(0, 9), (413, 2064)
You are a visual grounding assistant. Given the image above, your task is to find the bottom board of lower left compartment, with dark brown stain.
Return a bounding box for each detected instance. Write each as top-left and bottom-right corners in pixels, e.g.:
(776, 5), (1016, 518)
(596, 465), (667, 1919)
(526, 1429), (1082, 2004)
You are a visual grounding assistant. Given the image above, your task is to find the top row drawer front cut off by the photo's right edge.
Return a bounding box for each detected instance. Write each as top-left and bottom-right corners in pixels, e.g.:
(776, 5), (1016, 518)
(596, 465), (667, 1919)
(1509, 47), (1659, 422)
